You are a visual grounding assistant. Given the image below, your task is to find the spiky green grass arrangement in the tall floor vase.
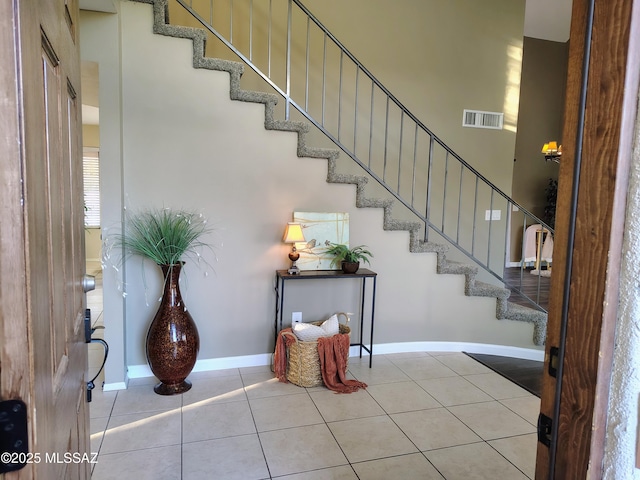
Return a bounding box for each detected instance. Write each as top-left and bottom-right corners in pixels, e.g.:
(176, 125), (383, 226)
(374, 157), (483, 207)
(116, 208), (212, 265)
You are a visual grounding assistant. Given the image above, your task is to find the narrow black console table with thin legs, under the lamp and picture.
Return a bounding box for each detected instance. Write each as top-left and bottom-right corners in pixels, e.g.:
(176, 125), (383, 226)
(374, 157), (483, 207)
(274, 268), (378, 368)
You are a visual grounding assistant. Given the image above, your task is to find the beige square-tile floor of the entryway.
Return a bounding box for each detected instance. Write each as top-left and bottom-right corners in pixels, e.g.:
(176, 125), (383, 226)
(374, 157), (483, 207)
(88, 276), (540, 480)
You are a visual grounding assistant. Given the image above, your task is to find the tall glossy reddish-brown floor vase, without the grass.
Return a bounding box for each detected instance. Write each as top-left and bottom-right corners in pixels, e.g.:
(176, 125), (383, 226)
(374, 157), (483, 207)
(147, 263), (200, 395)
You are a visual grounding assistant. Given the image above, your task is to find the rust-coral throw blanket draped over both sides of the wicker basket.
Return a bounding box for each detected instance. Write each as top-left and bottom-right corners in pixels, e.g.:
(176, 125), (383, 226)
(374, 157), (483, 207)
(273, 328), (367, 393)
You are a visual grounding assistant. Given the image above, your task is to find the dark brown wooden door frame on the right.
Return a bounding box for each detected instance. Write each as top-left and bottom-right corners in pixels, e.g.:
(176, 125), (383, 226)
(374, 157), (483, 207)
(536, 0), (640, 479)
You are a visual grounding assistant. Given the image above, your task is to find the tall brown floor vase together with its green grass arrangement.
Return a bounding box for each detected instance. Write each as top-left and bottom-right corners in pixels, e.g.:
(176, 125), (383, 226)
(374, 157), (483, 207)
(115, 208), (211, 395)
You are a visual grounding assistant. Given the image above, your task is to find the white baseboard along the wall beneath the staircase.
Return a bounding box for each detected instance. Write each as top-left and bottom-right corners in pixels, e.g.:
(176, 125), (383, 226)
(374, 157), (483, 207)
(112, 342), (544, 391)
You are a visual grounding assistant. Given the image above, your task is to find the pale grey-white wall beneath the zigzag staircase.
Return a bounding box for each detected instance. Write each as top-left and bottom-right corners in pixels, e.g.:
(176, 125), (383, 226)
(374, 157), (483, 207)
(83, 2), (533, 382)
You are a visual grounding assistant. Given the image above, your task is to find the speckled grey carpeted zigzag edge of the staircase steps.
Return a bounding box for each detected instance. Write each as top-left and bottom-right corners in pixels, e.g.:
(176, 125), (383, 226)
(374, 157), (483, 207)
(134, 0), (547, 346)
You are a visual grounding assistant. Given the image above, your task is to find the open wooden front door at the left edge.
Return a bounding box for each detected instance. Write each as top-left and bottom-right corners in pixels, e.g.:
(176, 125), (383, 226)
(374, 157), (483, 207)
(0, 0), (90, 480)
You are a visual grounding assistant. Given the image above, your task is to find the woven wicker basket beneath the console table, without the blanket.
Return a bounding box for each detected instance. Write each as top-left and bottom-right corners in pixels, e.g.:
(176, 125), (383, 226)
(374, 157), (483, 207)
(282, 313), (351, 387)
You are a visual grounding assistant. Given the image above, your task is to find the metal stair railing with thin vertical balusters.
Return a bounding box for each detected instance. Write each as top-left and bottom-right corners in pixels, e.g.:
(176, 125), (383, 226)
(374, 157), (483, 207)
(173, 0), (553, 312)
